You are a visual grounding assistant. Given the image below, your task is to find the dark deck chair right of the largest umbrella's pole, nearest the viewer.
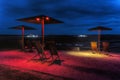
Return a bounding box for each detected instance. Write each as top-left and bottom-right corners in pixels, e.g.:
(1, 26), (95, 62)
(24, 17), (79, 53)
(48, 41), (61, 65)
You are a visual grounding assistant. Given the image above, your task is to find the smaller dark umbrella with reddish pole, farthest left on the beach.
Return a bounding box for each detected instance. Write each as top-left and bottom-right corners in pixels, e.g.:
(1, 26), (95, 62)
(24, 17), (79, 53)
(9, 25), (36, 49)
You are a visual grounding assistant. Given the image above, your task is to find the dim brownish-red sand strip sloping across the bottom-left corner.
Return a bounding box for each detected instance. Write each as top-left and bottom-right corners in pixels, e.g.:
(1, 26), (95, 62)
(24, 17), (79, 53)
(0, 65), (67, 80)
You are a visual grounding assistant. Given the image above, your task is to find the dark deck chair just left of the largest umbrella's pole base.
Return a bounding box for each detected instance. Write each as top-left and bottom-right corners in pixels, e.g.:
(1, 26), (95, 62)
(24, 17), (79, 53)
(32, 41), (46, 61)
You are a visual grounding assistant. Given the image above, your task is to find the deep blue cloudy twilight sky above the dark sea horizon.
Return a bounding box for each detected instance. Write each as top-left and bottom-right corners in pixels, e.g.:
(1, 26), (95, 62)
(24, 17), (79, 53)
(0, 0), (120, 35)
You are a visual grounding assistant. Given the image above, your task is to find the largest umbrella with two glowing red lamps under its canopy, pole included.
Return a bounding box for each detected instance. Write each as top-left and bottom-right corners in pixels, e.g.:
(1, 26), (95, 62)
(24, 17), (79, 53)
(18, 15), (63, 45)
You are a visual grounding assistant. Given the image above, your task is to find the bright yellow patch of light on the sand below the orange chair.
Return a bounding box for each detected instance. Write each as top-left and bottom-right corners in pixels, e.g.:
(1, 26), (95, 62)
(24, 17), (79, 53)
(67, 51), (107, 58)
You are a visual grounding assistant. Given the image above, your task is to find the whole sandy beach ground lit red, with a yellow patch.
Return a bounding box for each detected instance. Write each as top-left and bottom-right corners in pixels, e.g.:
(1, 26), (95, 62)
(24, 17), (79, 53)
(0, 50), (120, 80)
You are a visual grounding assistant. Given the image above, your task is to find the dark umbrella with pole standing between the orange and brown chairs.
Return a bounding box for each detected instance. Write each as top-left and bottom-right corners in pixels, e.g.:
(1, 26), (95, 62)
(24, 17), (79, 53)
(88, 26), (112, 51)
